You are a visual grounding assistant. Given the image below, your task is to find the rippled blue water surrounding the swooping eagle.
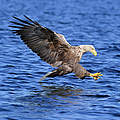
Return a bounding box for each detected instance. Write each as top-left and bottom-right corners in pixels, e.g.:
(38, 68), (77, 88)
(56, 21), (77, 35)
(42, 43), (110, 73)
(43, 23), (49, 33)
(0, 0), (120, 120)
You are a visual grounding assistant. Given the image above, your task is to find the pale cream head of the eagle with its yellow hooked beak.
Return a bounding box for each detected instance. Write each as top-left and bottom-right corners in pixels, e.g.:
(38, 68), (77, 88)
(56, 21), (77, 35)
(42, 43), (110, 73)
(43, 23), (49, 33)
(79, 45), (97, 56)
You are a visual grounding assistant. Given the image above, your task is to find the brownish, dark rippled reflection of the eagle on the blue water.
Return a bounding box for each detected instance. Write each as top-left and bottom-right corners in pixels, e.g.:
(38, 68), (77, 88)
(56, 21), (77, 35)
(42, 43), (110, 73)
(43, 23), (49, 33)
(16, 83), (83, 108)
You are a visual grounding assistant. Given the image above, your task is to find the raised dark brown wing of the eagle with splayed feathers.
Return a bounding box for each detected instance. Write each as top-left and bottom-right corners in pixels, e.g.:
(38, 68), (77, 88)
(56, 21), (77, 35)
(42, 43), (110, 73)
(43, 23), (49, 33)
(9, 16), (70, 67)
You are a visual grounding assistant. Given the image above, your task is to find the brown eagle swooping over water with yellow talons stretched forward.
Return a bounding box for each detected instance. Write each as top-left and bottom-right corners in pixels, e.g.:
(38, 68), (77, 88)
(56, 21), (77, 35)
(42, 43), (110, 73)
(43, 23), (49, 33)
(9, 15), (102, 80)
